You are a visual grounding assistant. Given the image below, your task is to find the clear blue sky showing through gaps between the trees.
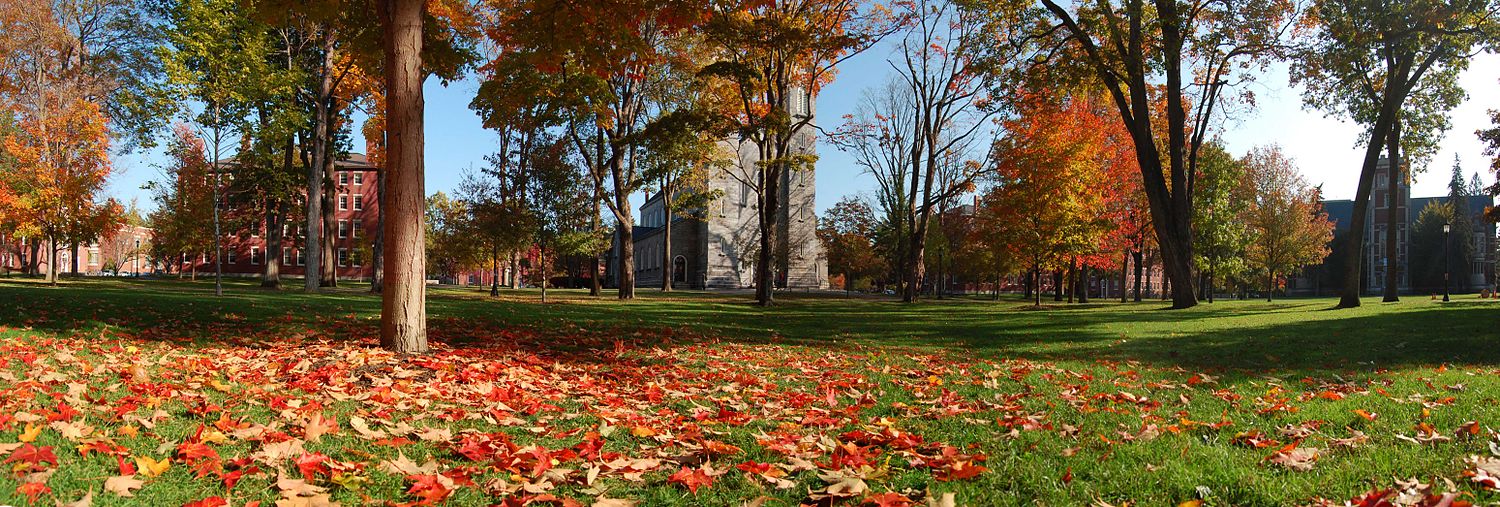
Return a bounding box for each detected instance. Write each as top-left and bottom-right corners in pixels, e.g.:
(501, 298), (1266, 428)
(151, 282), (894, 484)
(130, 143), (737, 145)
(108, 45), (1500, 217)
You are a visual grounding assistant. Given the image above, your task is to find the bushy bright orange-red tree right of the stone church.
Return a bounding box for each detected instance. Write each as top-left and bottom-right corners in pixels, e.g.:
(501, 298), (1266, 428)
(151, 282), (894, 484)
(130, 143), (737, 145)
(975, 92), (1139, 305)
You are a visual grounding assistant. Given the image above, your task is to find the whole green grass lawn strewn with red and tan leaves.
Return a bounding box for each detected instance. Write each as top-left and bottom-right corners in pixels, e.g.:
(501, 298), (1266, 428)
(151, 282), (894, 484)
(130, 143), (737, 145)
(0, 281), (1500, 506)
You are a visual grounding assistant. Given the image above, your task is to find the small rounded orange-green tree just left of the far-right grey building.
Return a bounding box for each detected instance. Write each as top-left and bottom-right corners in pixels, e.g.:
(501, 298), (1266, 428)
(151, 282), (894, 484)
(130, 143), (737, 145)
(1241, 146), (1334, 302)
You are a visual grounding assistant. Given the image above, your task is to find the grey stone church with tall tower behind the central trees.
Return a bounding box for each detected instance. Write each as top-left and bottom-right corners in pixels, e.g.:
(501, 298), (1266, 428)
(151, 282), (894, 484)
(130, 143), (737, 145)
(605, 93), (828, 290)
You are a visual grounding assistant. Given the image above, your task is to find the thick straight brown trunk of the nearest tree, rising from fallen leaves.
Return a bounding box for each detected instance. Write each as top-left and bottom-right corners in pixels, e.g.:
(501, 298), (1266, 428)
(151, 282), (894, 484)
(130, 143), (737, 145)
(380, 0), (428, 354)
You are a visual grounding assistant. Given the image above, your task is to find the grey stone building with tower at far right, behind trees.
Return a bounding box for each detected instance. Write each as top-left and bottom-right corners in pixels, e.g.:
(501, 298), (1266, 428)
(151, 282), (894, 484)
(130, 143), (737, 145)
(1308, 158), (1496, 294)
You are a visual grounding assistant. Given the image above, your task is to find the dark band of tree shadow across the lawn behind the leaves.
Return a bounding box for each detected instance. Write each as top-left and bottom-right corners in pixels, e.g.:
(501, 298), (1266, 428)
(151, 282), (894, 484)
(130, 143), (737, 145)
(0, 281), (1500, 375)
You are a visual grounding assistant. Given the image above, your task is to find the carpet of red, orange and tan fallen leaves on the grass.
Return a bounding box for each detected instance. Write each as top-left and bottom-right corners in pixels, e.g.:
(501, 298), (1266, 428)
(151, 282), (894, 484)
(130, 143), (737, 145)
(0, 309), (1500, 506)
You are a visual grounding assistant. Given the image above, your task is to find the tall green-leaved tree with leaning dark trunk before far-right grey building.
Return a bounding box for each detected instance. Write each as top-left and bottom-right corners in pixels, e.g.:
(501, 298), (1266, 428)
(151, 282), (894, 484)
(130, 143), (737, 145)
(1293, 0), (1500, 308)
